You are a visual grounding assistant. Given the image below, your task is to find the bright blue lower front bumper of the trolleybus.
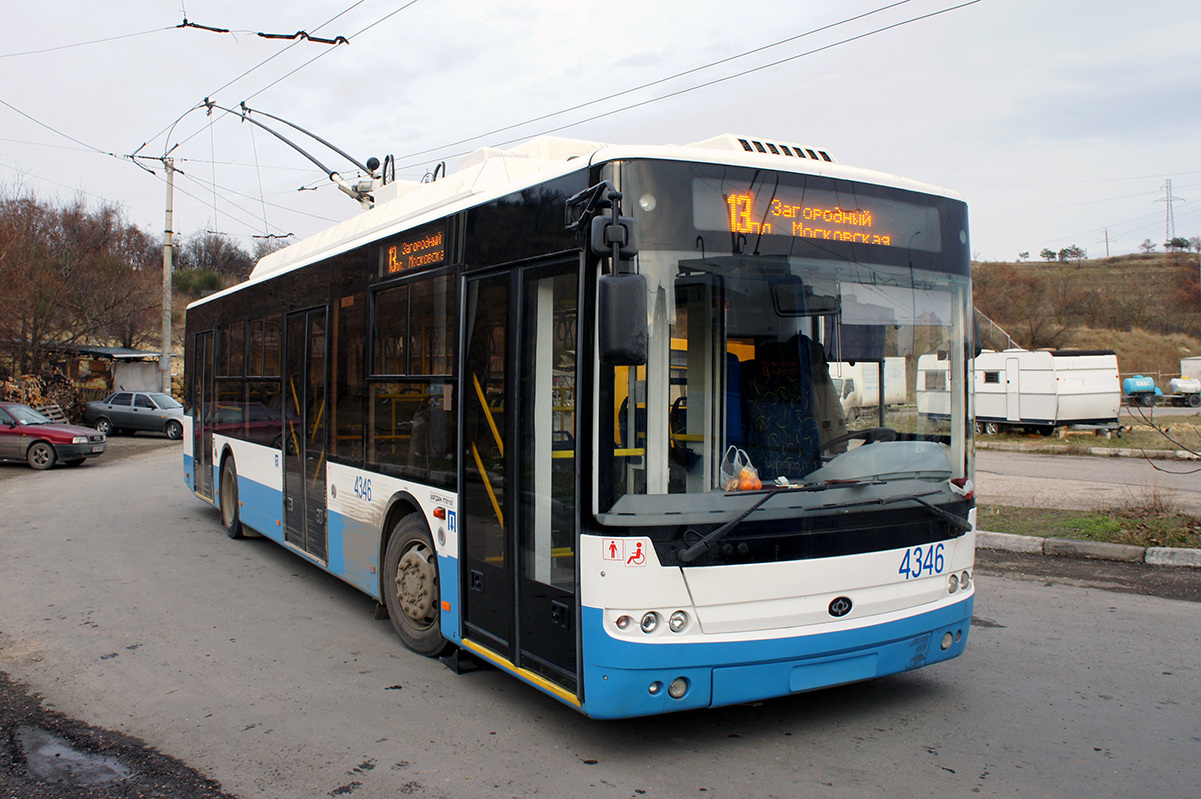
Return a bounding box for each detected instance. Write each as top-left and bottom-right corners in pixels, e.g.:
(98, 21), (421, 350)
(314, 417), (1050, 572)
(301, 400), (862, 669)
(582, 597), (974, 718)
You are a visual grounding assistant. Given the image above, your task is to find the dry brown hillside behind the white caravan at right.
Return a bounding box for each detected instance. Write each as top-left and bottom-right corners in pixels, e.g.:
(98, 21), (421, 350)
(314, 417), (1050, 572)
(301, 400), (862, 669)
(973, 254), (1201, 383)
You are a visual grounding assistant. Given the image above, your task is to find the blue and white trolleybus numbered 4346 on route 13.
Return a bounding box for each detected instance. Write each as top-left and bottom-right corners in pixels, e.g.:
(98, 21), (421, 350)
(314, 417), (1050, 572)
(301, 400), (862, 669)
(184, 136), (975, 717)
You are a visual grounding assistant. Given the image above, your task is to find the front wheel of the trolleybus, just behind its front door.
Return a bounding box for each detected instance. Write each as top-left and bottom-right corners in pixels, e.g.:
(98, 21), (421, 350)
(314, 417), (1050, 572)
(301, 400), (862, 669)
(381, 513), (447, 657)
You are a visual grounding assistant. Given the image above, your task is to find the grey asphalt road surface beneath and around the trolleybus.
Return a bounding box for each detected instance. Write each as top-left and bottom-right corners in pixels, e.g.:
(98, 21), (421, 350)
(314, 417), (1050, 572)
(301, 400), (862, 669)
(0, 439), (1201, 799)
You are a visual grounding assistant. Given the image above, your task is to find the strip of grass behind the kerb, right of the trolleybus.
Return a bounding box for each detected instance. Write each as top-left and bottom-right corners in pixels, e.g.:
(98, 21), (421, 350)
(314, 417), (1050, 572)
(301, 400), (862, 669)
(976, 495), (1201, 549)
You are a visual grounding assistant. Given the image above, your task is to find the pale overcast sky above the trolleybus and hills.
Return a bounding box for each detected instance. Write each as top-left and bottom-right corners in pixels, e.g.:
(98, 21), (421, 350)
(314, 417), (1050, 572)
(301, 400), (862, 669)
(0, 0), (1201, 261)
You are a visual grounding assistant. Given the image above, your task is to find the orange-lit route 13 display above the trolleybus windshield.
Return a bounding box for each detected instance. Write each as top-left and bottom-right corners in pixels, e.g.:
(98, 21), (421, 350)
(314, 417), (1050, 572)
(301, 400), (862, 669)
(692, 178), (942, 252)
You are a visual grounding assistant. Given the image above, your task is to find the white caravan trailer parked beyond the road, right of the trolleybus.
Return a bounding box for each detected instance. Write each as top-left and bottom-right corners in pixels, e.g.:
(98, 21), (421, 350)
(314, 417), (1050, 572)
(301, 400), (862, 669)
(974, 350), (1122, 434)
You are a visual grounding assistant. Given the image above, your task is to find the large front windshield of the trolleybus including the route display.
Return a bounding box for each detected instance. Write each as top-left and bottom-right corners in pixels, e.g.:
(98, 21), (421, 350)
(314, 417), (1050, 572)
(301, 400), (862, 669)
(597, 162), (970, 524)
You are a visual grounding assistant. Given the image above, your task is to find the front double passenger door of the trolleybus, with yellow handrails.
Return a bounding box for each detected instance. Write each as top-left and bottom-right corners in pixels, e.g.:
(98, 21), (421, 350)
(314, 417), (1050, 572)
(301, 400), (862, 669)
(461, 258), (579, 692)
